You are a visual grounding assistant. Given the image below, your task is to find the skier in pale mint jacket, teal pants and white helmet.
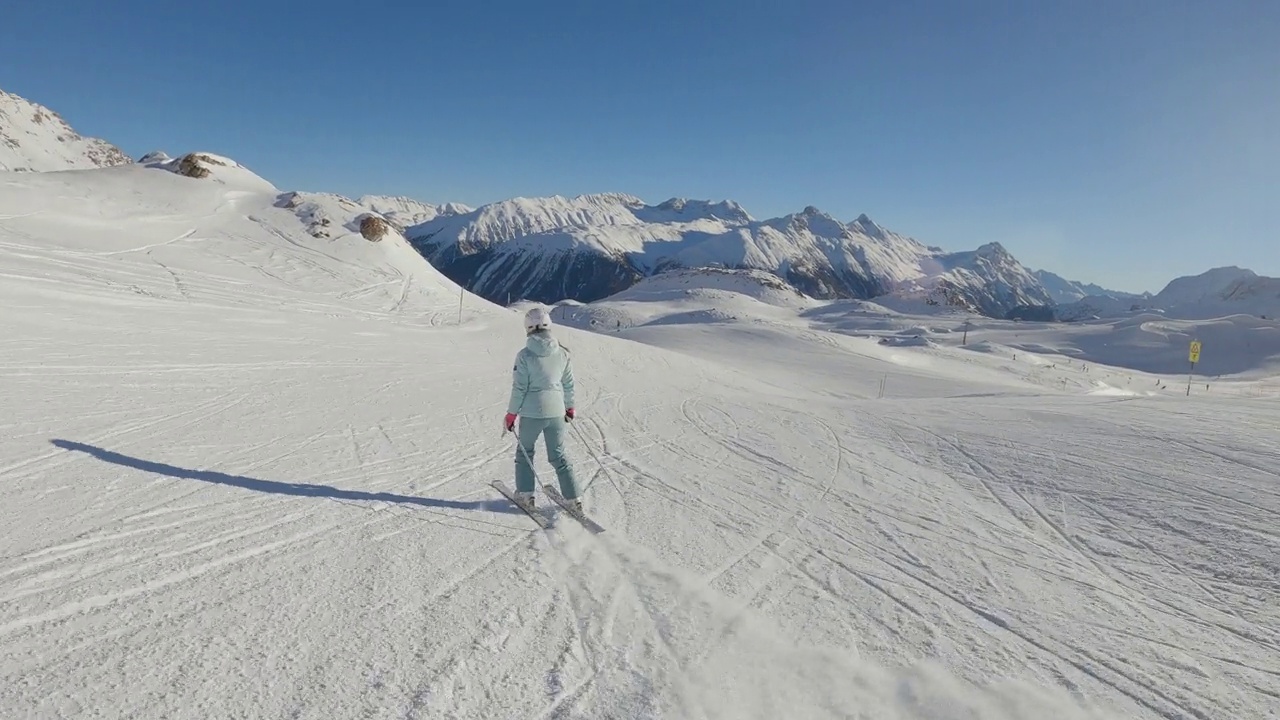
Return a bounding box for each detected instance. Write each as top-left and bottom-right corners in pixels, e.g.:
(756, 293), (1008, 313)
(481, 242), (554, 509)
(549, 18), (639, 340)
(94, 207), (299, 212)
(503, 307), (582, 510)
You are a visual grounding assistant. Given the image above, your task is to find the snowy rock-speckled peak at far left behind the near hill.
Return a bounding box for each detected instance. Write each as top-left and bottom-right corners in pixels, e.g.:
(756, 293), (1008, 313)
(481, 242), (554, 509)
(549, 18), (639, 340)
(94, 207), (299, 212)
(0, 90), (132, 172)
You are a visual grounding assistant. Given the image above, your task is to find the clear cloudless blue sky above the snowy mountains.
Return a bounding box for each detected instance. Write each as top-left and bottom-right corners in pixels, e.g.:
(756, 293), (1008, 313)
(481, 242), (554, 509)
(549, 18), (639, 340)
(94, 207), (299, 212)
(0, 0), (1280, 291)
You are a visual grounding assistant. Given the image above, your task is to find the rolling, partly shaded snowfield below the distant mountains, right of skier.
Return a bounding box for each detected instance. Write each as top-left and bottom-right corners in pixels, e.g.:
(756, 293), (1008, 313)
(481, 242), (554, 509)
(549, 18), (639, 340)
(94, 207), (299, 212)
(565, 263), (1280, 376)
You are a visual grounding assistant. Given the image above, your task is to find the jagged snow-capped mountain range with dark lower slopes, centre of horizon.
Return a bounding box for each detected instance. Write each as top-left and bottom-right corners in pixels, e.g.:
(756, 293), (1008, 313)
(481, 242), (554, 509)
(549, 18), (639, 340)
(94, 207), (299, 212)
(406, 193), (1051, 316)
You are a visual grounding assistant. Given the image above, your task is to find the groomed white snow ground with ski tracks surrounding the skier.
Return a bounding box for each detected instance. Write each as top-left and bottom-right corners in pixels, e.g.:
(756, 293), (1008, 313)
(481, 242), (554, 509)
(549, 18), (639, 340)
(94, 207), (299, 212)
(0, 167), (1280, 720)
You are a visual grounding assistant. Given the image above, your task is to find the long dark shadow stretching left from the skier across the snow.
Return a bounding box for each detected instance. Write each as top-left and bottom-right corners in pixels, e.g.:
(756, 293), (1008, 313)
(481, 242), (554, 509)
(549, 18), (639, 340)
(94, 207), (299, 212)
(49, 439), (520, 514)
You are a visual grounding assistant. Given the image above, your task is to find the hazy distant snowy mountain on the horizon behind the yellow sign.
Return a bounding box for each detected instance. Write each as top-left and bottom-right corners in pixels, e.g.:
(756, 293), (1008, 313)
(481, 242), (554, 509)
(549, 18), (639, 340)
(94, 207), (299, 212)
(1057, 266), (1280, 320)
